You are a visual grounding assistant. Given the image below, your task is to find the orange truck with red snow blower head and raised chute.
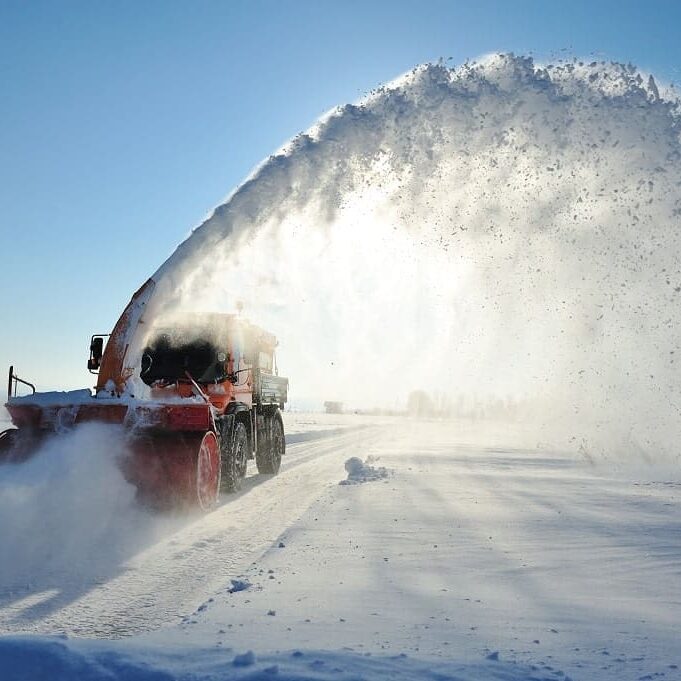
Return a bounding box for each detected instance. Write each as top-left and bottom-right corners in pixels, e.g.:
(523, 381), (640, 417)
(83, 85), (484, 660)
(0, 279), (288, 510)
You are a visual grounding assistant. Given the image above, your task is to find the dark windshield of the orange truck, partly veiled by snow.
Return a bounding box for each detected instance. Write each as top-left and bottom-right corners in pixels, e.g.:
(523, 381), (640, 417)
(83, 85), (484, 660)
(140, 333), (227, 385)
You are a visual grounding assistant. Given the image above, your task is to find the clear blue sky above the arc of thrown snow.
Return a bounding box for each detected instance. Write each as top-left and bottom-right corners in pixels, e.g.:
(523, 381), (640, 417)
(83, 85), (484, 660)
(0, 0), (681, 389)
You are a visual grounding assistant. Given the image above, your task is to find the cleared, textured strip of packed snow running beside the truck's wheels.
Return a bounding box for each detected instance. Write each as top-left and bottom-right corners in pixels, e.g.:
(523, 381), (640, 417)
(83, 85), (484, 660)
(0, 426), (381, 638)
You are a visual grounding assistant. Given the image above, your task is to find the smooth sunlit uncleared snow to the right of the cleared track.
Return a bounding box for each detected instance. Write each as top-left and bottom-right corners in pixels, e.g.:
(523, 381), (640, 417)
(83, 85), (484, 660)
(141, 423), (681, 679)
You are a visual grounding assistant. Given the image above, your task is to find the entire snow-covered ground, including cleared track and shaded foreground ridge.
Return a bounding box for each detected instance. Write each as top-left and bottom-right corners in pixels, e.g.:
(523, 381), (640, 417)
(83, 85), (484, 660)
(0, 414), (681, 680)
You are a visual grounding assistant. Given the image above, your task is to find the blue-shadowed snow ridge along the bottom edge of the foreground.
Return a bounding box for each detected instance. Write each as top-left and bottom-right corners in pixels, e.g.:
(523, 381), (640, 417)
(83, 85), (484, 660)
(0, 637), (569, 681)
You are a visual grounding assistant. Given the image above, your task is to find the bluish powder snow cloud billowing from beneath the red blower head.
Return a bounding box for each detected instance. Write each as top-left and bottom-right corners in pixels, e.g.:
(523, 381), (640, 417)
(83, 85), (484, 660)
(0, 424), (173, 589)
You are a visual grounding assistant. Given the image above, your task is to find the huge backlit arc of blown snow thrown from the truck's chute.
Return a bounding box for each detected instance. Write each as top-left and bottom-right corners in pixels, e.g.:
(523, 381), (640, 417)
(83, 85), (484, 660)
(139, 55), (681, 456)
